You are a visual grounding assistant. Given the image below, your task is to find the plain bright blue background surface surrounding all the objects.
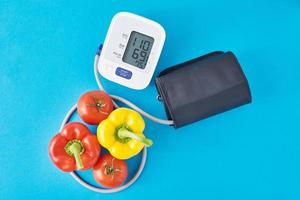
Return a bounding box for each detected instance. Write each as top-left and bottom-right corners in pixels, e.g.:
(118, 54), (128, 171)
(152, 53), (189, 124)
(0, 0), (300, 200)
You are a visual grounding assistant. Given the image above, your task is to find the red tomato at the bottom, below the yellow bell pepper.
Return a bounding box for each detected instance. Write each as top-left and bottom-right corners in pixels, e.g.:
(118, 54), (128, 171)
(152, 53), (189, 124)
(93, 154), (128, 188)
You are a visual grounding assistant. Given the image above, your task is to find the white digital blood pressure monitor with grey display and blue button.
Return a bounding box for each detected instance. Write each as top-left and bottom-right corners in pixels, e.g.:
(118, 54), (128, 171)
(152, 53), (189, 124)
(98, 12), (166, 89)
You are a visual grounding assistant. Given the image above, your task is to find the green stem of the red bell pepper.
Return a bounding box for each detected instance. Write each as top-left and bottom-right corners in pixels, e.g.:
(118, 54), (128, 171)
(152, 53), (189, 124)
(65, 140), (84, 169)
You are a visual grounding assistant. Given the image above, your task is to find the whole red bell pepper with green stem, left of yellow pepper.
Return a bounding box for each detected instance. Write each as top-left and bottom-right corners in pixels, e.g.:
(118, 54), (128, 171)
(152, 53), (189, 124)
(49, 122), (100, 172)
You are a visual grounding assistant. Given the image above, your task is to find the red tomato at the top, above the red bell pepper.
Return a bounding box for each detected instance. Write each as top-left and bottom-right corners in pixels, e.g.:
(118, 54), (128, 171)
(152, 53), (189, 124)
(77, 91), (113, 125)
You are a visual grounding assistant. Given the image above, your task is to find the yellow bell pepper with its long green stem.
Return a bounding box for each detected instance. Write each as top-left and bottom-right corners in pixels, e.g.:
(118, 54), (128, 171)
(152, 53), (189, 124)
(97, 108), (152, 160)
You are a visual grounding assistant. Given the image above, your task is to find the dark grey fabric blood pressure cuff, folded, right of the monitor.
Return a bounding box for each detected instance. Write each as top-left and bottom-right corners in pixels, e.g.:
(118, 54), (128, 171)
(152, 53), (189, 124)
(155, 51), (251, 128)
